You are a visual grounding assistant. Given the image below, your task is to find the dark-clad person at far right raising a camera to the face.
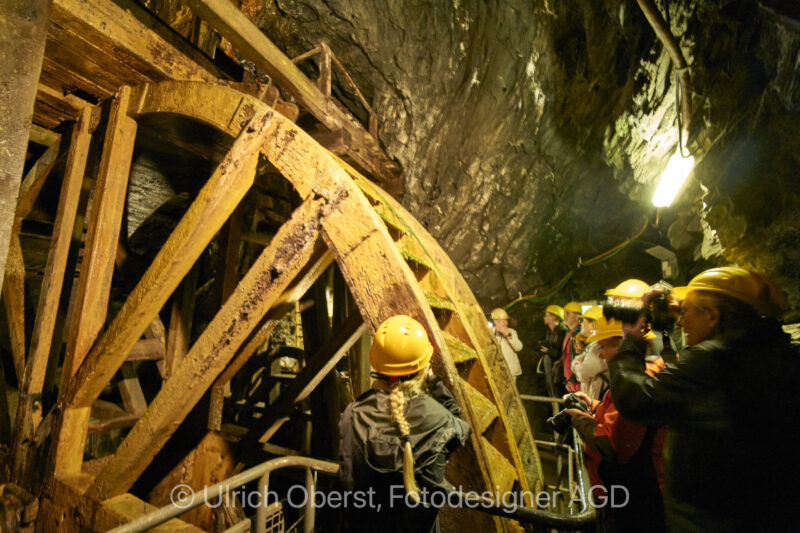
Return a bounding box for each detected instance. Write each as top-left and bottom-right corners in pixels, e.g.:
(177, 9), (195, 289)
(609, 266), (800, 531)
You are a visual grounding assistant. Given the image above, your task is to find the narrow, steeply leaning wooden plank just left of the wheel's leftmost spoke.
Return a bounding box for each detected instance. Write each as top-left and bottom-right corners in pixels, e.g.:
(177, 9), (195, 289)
(12, 108), (92, 480)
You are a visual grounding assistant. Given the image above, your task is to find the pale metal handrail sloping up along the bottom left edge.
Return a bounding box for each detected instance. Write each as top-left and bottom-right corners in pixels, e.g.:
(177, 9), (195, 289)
(109, 457), (339, 533)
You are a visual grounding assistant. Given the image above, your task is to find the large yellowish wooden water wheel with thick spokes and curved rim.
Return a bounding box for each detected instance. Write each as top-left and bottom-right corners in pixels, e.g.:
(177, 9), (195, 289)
(20, 82), (542, 531)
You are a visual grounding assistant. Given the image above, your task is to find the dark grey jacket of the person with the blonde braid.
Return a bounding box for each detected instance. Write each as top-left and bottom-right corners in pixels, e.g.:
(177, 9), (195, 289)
(339, 377), (470, 533)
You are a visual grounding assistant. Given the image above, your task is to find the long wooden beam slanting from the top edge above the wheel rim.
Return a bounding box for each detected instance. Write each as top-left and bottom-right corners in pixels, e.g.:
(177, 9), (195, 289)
(186, 0), (403, 194)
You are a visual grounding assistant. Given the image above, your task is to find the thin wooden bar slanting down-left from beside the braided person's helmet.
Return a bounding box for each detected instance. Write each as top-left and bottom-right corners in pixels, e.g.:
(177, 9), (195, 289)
(244, 313), (368, 449)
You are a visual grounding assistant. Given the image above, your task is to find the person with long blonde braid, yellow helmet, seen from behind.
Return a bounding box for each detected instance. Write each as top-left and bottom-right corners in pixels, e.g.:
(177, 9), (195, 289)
(339, 315), (470, 533)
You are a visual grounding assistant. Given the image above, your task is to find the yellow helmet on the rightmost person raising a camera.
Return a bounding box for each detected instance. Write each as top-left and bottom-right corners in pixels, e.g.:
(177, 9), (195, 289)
(688, 266), (786, 318)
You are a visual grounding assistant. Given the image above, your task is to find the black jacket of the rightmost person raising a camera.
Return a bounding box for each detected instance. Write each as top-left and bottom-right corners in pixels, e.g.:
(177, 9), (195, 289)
(608, 320), (800, 531)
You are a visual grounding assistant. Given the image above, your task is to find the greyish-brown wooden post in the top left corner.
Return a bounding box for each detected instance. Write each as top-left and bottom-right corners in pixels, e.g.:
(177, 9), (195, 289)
(0, 0), (50, 300)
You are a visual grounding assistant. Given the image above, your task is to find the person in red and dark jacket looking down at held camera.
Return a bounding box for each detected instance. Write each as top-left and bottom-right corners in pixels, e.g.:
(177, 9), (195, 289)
(564, 317), (666, 533)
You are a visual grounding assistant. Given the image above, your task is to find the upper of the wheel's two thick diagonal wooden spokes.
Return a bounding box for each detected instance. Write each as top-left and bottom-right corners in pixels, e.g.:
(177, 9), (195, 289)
(63, 106), (275, 407)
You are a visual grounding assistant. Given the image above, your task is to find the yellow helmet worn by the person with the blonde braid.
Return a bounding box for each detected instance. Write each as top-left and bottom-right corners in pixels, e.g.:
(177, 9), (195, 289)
(369, 315), (433, 376)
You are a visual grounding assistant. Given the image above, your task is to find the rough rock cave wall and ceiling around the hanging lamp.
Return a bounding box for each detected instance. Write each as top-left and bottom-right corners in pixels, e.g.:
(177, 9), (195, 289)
(153, 0), (800, 308)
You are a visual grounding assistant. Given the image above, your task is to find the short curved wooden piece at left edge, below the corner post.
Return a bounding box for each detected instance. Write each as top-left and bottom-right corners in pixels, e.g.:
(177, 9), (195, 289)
(3, 233), (25, 383)
